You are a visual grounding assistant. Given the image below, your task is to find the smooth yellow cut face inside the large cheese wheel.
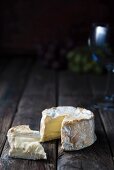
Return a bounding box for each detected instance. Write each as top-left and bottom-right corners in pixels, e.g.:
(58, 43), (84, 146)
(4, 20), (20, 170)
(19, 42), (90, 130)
(40, 115), (65, 142)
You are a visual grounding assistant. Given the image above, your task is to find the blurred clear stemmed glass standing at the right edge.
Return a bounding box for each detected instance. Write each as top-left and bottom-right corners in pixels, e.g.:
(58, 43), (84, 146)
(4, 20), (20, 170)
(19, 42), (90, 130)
(88, 24), (114, 109)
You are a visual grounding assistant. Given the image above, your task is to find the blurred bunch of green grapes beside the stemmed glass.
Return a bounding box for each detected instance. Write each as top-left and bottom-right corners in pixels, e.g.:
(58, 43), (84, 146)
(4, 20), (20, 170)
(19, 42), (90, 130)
(67, 47), (103, 74)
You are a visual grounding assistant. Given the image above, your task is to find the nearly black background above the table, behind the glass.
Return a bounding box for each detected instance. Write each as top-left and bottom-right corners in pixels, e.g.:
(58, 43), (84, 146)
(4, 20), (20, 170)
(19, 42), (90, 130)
(0, 0), (114, 55)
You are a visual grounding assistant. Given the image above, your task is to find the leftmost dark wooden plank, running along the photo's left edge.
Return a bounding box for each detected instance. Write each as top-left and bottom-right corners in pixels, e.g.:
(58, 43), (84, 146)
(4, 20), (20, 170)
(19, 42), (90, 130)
(0, 59), (31, 154)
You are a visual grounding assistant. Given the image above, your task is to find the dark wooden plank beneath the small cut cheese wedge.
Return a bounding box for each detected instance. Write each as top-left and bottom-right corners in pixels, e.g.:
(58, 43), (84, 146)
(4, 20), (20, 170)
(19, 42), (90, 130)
(2, 67), (56, 170)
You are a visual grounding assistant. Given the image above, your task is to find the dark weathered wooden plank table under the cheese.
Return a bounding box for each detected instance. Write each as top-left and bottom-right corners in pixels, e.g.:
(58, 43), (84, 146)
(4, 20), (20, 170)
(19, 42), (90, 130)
(0, 58), (114, 170)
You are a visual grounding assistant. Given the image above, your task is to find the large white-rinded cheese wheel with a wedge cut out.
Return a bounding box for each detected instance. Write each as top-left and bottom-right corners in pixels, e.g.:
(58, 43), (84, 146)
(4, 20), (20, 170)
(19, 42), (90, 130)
(40, 106), (96, 150)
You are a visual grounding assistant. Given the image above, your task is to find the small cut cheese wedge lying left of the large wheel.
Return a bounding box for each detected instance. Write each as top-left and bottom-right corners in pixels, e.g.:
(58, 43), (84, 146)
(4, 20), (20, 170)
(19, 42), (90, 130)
(7, 125), (47, 160)
